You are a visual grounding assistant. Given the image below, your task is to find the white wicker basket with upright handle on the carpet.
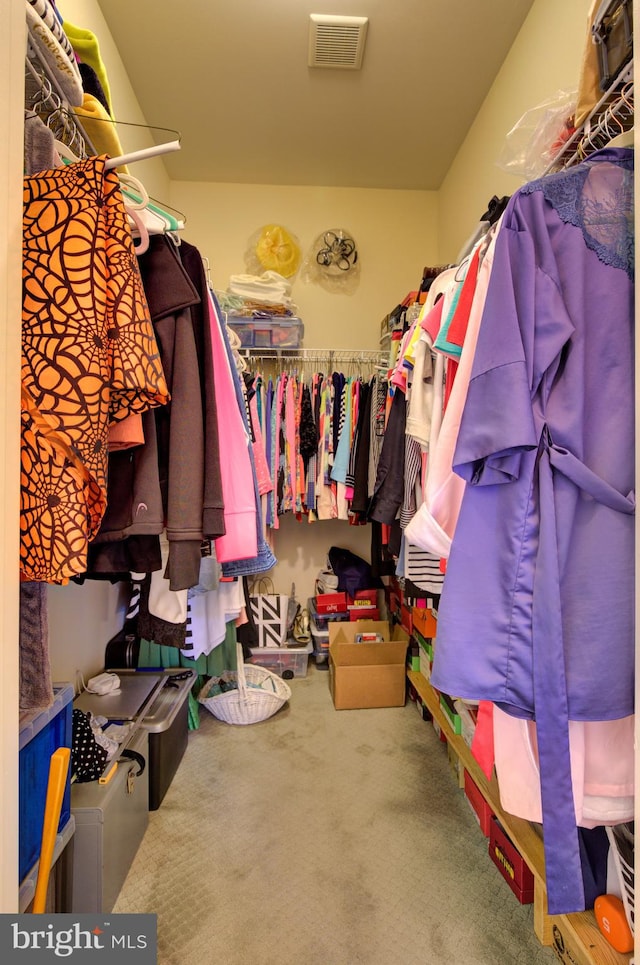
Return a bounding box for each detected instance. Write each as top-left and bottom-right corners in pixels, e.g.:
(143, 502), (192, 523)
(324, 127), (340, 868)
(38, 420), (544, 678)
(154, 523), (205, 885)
(198, 644), (291, 724)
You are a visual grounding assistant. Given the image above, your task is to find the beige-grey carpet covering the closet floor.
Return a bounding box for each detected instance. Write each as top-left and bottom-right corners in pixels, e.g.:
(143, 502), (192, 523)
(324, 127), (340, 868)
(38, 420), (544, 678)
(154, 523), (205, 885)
(114, 659), (556, 965)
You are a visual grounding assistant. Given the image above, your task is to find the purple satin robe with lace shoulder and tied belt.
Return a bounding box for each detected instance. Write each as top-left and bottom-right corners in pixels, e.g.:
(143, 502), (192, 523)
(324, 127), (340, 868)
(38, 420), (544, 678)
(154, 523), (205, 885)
(432, 148), (634, 914)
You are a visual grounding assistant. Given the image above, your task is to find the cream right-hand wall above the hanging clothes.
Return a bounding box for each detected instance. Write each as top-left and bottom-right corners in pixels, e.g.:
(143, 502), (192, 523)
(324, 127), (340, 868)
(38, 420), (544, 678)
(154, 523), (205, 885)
(438, 0), (591, 261)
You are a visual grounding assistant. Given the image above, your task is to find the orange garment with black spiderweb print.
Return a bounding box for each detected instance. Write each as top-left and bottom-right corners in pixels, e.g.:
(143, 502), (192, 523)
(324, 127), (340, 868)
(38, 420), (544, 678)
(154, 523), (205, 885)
(21, 157), (169, 582)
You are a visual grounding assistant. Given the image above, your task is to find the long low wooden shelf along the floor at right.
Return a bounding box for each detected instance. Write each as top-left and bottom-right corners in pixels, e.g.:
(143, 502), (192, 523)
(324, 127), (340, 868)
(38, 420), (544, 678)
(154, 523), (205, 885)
(407, 670), (632, 965)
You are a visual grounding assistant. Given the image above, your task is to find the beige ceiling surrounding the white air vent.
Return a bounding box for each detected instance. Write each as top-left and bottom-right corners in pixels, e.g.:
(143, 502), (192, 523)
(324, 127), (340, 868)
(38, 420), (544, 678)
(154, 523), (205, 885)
(100, 0), (533, 190)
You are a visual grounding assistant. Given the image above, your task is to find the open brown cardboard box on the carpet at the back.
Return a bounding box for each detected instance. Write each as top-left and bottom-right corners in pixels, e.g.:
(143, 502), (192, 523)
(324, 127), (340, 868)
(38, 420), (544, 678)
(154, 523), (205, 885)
(329, 620), (409, 710)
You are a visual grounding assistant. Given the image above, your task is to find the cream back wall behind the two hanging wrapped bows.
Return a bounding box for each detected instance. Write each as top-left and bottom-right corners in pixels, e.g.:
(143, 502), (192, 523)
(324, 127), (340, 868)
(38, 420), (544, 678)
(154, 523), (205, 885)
(170, 181), (437, 349)
